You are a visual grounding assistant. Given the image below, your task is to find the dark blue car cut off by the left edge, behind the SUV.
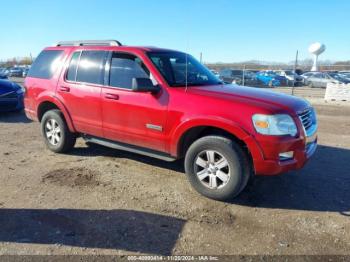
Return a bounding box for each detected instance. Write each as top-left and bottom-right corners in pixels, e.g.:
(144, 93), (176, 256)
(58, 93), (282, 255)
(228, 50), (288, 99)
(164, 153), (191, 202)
(0, 80), (24, 112)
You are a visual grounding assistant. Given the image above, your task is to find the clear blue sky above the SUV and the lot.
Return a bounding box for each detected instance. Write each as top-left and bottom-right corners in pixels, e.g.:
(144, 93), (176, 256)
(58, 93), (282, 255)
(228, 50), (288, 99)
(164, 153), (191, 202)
(0, 0), (350, 62)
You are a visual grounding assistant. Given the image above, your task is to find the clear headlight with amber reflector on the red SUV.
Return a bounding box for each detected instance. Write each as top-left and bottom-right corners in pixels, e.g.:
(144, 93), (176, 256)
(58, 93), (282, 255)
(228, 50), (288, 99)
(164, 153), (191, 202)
(252, 114), (298, 136)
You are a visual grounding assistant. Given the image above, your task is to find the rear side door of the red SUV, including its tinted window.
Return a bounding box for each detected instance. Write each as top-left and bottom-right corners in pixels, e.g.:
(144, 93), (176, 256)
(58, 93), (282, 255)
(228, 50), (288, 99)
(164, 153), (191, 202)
(56, 50), (108, 137)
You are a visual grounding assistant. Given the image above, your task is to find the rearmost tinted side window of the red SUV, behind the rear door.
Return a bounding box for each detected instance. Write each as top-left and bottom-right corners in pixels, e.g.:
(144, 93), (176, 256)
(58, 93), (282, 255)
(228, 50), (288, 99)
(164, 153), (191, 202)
(28, 50), (63, 79)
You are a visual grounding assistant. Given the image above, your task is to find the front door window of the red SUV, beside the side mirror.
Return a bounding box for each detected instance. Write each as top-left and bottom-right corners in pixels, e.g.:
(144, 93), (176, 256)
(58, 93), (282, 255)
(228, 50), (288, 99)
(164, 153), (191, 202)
(109, 53), (150, 89)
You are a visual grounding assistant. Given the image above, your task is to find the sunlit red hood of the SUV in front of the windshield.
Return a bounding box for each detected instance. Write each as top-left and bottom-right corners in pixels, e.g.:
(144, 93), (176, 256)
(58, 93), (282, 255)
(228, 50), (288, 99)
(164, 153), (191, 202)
(188, 85), (310, 115)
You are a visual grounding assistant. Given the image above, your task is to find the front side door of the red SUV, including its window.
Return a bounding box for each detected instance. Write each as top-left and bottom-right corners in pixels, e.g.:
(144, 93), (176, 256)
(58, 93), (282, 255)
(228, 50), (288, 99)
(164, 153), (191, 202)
(102, 52), (168, 152)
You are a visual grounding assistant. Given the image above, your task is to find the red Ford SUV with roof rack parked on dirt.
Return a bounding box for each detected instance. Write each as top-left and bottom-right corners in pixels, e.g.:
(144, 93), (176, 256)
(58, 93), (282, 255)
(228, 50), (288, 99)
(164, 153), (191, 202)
(25, 41), (317, 200)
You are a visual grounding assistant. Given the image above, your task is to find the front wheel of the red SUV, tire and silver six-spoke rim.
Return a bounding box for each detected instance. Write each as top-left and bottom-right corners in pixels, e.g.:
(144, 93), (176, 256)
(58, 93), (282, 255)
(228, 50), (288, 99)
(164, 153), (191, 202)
(185, 136), (252, 201)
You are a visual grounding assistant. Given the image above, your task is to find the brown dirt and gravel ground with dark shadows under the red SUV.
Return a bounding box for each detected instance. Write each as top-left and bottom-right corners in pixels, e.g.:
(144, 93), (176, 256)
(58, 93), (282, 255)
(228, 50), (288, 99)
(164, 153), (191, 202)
(0, 85), (350, 255)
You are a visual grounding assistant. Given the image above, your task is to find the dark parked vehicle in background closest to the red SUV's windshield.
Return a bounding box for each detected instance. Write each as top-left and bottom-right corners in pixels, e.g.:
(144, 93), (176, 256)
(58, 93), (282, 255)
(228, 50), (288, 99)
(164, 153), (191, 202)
(219, 69), (256, 85)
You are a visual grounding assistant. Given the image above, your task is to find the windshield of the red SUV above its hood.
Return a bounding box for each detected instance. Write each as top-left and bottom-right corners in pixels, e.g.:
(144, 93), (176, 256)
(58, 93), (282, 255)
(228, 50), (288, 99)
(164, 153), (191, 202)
(148, 52), (222, 87)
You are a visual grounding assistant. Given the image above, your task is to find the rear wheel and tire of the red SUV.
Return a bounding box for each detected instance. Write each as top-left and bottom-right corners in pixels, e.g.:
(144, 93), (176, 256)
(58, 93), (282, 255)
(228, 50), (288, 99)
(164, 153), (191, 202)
(41, 109), (76, 153)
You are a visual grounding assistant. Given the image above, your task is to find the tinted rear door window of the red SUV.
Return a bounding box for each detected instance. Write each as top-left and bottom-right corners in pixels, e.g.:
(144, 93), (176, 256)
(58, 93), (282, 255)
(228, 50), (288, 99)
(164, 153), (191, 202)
(76, 51), (108, 84)
